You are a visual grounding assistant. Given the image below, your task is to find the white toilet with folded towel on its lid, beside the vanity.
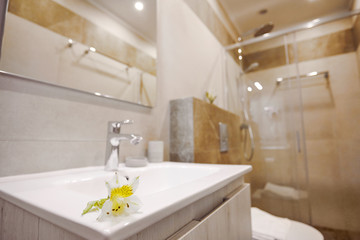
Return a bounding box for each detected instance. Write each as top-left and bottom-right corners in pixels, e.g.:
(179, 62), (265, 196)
(251, 207), (324, 240)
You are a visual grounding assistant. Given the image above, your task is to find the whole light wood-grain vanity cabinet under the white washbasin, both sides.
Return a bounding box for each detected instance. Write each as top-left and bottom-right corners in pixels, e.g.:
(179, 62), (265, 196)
(0, 176), (251, 240)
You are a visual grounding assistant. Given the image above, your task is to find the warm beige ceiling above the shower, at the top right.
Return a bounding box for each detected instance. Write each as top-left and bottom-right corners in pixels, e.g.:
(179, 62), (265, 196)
(218, 0), (353, 38)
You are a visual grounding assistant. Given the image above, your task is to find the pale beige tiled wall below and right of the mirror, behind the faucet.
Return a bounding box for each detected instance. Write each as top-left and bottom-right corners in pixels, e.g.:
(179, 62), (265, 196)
(0, 0), (242, 176)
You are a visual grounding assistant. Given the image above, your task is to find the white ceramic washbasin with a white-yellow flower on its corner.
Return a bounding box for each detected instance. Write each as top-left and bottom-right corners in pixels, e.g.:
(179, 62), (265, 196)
(0, 162), (251, 239)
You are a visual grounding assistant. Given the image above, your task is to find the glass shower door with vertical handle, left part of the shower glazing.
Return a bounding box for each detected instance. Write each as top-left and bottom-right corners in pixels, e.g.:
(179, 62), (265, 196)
(241, 34), (310, 223)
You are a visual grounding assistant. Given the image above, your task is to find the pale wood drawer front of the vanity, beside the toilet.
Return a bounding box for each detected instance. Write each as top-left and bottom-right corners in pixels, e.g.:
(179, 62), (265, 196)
(179, 184), (251, 240)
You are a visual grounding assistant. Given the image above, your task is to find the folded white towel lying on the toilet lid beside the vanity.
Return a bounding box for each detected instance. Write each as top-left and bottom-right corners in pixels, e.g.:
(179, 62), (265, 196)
(251, 207), (291, 240)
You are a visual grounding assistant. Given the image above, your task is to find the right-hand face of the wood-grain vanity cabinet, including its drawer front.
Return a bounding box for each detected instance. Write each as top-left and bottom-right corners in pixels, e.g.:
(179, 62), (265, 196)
(127, 177), (251, 240)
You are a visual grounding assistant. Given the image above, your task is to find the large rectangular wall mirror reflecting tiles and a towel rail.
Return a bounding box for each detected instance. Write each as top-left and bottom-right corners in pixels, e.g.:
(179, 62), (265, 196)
(0, 0), (156, 107)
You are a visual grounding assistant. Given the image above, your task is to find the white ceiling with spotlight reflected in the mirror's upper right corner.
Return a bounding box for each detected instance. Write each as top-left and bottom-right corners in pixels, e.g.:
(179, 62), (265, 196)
(89, 0), (156, 43)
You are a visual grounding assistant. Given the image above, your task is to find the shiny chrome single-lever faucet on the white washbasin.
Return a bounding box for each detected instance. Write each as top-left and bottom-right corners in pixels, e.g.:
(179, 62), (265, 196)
(105, 120), (143, 171)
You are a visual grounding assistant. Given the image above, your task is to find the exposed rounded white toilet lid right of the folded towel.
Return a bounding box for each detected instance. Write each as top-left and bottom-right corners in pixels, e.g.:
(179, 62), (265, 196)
(286, 220), (324, 240)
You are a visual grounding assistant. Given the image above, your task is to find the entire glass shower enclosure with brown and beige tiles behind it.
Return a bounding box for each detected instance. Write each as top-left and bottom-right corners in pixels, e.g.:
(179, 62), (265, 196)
(239, 14), (360, 232)
